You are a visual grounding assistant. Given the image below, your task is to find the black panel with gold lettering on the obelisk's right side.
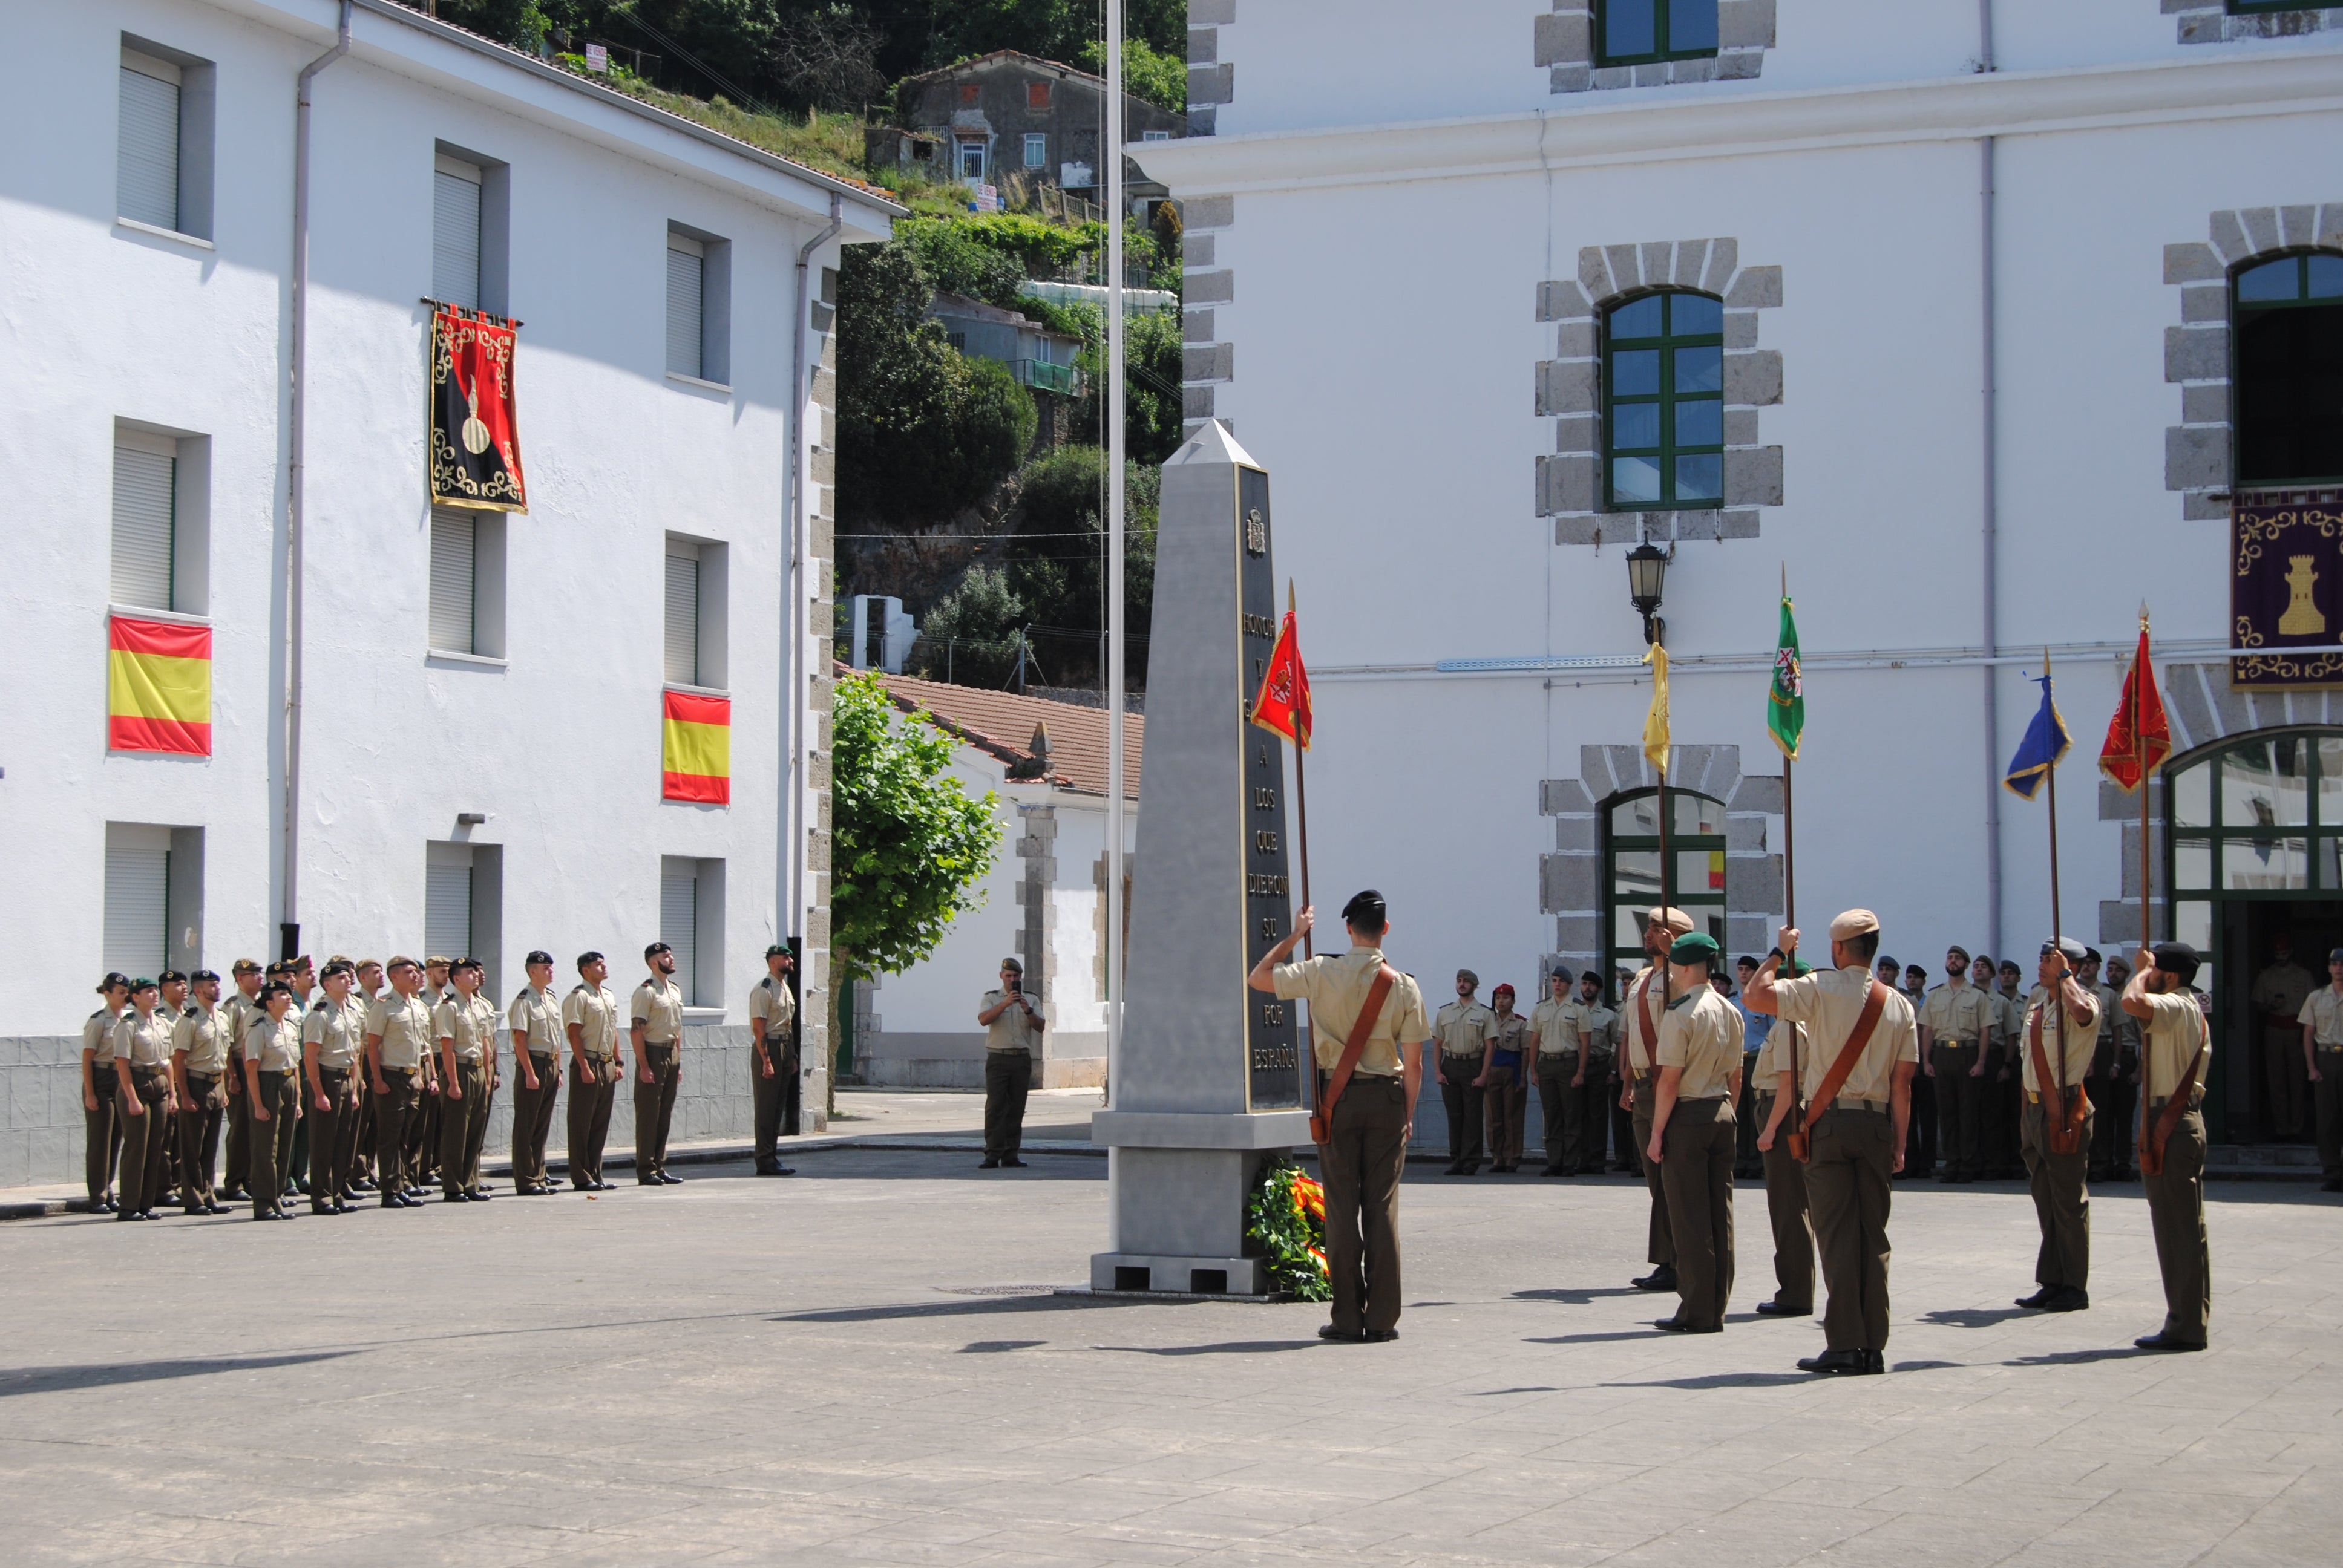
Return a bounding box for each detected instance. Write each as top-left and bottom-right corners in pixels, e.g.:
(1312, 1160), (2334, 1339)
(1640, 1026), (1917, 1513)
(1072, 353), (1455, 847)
(1237, 466), (1303, 1111)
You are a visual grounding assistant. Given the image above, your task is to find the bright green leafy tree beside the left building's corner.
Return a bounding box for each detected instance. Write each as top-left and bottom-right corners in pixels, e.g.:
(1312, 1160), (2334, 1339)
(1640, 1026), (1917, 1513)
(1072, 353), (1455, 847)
(830, 675), (1000, 1078)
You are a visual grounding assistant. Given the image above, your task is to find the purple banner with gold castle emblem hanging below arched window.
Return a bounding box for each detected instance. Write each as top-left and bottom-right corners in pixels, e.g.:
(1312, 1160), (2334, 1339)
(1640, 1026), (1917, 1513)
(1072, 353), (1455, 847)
(2228, 506), (2343, 691)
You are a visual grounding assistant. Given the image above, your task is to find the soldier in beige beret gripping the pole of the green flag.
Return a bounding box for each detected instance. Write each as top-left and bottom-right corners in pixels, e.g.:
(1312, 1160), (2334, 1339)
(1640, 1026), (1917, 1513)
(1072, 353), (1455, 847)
(1750, 909), (1919, 1373)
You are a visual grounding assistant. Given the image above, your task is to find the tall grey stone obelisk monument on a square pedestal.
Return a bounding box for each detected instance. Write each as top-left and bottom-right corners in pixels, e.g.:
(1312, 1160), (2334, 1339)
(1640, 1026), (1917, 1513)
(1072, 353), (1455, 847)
(1089, 422), (1309, 1296)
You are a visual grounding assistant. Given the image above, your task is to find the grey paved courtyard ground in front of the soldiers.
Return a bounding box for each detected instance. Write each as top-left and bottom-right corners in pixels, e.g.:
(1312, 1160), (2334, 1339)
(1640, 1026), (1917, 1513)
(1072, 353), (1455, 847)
(0, 1148), (2343, 1568)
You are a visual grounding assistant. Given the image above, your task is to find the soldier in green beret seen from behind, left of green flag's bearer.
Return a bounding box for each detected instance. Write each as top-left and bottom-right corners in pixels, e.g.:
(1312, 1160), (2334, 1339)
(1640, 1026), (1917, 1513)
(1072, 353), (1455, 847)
(1645, 930), (1741, 1334)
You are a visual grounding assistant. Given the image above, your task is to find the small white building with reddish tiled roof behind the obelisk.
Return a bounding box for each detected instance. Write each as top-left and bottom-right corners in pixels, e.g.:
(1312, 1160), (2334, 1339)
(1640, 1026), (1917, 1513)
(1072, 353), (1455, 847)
(841, 675), (1145, 1090)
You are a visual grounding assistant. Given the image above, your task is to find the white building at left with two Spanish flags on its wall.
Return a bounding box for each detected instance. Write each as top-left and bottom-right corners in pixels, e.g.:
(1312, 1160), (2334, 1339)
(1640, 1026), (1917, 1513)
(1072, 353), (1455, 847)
(0, 0), (900, 1186)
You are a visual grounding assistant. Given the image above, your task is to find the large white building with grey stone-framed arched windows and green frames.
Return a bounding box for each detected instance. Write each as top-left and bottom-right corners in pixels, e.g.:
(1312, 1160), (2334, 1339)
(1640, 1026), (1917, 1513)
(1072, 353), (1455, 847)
(1144, 0), (2343, 1139)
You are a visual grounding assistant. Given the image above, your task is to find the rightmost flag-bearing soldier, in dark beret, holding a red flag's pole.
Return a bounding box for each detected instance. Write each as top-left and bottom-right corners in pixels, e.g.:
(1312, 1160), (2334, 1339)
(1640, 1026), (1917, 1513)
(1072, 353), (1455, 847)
(2123, 942), (2212, 1350)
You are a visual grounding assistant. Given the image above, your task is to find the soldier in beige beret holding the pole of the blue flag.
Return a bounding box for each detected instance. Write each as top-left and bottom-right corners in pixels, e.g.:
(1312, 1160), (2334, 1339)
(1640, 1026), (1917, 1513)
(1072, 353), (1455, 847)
(2017, 938), (2099, 1313)
